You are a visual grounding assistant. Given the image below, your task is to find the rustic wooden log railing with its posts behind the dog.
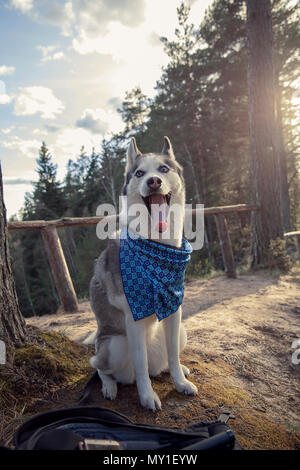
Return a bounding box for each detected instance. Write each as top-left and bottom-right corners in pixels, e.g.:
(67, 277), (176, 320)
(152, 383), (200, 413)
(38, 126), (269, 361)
(8, 204), (259, 312)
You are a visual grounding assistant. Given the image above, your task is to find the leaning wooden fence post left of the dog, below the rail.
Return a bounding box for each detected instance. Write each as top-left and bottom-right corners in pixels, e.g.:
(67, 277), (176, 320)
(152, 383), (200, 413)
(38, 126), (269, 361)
(41, 224), (79, 313)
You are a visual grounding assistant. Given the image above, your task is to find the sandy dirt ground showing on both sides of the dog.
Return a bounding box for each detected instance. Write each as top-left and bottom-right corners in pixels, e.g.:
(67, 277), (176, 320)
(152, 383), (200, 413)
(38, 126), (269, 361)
(28, 269), (300, 448)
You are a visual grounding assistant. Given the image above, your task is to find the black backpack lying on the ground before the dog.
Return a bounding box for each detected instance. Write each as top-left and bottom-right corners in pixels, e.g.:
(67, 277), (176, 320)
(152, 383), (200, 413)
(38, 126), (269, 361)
(14, 406), (242, 451)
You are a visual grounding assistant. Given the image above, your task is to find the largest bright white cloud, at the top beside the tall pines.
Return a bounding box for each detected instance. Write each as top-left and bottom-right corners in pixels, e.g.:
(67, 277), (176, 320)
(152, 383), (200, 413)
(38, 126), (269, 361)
(7, 0), (212, 107)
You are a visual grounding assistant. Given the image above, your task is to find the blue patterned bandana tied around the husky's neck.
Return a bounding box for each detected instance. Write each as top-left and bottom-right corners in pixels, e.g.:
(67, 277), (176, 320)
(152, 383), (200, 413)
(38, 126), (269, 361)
(120, 229), (192, 321)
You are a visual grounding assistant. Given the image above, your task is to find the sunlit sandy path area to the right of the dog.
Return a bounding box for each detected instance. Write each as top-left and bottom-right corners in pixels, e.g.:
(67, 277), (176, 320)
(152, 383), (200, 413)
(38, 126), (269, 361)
(185, 275), (300, 426)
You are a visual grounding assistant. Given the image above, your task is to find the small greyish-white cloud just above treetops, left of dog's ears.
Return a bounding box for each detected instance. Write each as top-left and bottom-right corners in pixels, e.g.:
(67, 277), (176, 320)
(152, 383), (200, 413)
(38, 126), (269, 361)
(76, 108), (124, 136)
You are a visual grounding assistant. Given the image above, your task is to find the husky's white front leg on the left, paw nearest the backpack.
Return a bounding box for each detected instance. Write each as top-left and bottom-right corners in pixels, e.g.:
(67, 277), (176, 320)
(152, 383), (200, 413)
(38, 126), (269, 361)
(126, 313), (161, 411)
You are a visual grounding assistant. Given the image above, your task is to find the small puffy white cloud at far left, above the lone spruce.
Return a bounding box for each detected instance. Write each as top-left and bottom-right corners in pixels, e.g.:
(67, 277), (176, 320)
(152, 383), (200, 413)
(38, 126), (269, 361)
(14, 86), (64, 119)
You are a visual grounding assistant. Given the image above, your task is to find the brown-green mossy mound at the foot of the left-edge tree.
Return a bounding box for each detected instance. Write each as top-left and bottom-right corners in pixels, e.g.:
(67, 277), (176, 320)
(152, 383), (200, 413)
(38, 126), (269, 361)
(0, 327), (91, 443)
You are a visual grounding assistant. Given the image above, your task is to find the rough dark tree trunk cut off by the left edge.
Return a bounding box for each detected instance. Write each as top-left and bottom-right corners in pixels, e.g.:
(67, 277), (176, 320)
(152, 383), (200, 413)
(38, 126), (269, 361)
(0, 165), (26, 344)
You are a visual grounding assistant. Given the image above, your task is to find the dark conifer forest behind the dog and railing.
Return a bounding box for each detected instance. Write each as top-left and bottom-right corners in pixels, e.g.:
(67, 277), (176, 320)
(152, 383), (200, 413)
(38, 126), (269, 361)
(10, 0), (300, 317)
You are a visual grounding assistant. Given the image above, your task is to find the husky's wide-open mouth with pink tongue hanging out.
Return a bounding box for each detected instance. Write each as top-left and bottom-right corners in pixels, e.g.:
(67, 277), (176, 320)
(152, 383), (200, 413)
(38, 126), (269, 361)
(143, 193), (171, 233)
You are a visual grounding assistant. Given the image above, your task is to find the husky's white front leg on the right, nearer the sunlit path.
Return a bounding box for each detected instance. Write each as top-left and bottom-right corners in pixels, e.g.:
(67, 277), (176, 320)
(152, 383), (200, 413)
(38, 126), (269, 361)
(163, 307), (198, 395)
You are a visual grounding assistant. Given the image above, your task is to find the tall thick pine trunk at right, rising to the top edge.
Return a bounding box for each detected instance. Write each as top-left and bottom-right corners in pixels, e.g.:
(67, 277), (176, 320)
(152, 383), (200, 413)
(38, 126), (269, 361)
(246, 0), (282, 267)
